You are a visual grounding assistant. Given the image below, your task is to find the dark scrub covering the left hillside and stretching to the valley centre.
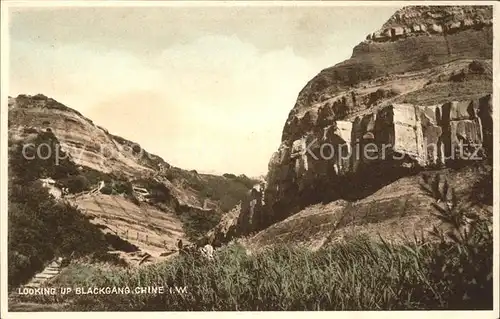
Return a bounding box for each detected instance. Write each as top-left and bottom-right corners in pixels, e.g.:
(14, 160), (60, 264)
(8, 131), (253, 287)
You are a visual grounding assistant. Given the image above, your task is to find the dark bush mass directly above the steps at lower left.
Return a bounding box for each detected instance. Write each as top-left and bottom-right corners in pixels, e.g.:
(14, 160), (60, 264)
(8, 182), (111, 288)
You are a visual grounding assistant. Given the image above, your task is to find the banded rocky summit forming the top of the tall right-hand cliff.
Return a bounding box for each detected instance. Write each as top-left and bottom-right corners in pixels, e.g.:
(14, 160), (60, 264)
(294, 6), (493, 112)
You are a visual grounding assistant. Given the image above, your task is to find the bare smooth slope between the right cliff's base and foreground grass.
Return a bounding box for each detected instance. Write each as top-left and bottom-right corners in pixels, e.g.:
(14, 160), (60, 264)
(243, 166), (493, 250)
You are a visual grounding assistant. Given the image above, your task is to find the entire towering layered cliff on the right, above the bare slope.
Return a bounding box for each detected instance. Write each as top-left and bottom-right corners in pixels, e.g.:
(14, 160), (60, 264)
(209, 6), (493, 245)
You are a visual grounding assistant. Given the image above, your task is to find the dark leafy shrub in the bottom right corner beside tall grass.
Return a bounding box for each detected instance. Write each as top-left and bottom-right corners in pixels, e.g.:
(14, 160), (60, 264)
(418, 174), (493, 309)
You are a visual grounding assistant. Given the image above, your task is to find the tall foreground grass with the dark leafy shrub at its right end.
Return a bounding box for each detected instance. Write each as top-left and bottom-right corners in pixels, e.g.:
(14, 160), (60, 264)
(18, 176), (493, 311)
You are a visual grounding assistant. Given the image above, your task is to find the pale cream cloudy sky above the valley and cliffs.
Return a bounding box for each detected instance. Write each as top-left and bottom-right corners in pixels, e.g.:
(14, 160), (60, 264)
(9, 6), (399, 176)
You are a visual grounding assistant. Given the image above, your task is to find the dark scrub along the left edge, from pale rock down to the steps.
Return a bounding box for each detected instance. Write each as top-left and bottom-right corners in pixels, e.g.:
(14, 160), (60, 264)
(8, 132), (125, 288)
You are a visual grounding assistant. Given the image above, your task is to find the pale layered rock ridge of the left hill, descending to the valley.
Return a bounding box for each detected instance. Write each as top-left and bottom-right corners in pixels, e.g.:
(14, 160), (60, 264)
(8, 94), (224, 213)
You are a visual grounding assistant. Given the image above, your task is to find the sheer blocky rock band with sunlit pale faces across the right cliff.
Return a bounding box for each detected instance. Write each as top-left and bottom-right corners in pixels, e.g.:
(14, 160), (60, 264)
(256, 95), (492, 229)
